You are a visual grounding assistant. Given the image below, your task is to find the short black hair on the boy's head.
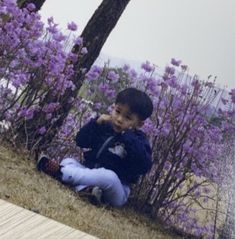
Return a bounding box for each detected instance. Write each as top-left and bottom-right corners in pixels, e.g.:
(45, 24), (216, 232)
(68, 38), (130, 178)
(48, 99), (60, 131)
(115, 88), (153, 120)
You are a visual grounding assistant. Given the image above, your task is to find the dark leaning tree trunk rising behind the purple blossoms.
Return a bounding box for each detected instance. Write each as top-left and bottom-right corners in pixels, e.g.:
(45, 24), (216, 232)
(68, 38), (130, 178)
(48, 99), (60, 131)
(16, 0), (130, 152)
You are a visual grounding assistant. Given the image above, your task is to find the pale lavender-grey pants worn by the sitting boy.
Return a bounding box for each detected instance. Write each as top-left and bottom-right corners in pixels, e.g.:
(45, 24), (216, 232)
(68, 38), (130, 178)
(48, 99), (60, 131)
(60, 158), (130, 206)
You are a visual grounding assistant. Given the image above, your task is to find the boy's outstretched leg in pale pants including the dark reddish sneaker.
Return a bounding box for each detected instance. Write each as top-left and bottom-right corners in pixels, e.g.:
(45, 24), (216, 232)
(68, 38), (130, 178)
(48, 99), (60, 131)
(37, 155), (130, 206)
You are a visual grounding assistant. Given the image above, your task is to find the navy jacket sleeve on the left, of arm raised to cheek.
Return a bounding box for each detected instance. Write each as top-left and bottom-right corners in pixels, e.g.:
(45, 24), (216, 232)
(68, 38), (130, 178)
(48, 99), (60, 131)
(76, 118), (102, 148)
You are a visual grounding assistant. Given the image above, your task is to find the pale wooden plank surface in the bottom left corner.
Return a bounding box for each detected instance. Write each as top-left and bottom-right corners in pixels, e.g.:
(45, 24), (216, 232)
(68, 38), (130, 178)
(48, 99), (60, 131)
(0, 199), (97, 239)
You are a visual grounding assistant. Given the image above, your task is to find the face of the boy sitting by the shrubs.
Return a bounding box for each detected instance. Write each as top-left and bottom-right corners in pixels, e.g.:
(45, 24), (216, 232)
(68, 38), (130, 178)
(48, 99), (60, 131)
(111, 103), (143, 133)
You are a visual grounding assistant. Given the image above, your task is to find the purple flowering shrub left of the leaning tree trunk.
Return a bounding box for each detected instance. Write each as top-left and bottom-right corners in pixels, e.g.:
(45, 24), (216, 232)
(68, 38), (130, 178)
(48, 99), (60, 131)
(0, 0), (86, 145)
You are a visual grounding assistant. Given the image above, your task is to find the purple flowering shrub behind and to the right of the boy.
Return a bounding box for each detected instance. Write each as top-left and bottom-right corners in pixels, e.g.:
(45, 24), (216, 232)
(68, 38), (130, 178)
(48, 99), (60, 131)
(70, 59), (235, 238)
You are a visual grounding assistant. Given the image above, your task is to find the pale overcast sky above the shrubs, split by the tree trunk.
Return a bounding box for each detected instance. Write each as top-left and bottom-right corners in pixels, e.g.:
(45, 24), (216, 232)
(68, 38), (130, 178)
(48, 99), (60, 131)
(41, 0), (235, 88)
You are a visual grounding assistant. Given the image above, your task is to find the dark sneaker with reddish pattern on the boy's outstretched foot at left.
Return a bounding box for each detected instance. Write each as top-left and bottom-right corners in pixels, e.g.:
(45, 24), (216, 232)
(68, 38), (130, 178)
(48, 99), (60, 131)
(37, 154), (61, 179)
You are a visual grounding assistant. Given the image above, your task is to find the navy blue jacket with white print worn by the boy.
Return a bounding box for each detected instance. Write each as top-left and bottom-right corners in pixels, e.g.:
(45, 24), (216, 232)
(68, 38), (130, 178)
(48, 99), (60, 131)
(76, 119), (152, 184)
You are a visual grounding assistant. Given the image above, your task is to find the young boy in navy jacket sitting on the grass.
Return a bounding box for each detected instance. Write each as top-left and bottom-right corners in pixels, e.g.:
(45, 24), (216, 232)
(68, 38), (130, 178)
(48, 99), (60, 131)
(37, 88), (153, 206)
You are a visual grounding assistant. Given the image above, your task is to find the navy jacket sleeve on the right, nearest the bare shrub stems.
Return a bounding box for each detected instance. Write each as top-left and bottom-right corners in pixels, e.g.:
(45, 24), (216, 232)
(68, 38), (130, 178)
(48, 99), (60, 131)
(123, 130), (152, 176)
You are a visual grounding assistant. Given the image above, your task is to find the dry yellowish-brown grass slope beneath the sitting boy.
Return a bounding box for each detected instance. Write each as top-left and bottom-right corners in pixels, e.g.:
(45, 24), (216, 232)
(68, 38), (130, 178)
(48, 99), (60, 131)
(0, 143), (182, 239)
